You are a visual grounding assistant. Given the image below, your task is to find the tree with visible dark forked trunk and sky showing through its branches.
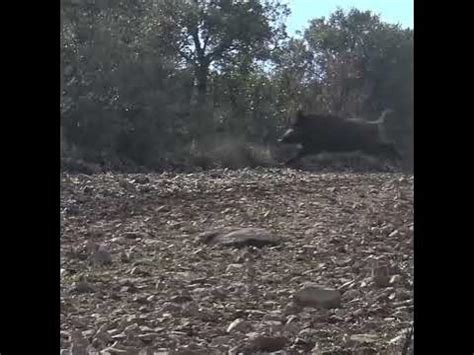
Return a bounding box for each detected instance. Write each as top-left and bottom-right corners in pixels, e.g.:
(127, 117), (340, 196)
(156, 0), (288, 105)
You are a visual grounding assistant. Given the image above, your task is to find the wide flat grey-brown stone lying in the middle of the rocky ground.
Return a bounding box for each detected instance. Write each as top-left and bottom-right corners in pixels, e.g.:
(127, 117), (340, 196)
(198, 228), (281, 248)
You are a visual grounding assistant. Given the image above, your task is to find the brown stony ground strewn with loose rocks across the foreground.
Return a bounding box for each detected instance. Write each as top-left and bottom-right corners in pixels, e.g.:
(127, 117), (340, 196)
(61, 169), (413, 354)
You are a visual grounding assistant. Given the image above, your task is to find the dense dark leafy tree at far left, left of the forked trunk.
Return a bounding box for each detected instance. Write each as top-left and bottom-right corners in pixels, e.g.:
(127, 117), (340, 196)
(61, 0), (190, 168)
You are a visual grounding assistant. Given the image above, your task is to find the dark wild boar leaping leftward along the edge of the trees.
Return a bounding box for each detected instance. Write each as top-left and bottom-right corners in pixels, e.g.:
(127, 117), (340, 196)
(278, 110), (401, 164)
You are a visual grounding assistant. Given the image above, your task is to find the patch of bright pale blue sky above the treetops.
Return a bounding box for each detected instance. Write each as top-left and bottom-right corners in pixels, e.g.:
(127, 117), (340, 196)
(286, 0), (413, 34)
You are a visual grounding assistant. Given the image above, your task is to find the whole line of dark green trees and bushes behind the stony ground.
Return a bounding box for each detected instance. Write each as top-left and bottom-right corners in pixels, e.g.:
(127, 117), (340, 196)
(60, 0), (413, 169)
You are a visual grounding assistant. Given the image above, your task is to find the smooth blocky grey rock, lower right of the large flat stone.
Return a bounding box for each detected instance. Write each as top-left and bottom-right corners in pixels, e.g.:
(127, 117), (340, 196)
(294, 286), (341, 309)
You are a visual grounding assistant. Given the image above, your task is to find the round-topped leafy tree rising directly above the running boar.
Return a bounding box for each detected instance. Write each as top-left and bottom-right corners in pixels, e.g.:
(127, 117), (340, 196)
(305, 9), (413, 116)
